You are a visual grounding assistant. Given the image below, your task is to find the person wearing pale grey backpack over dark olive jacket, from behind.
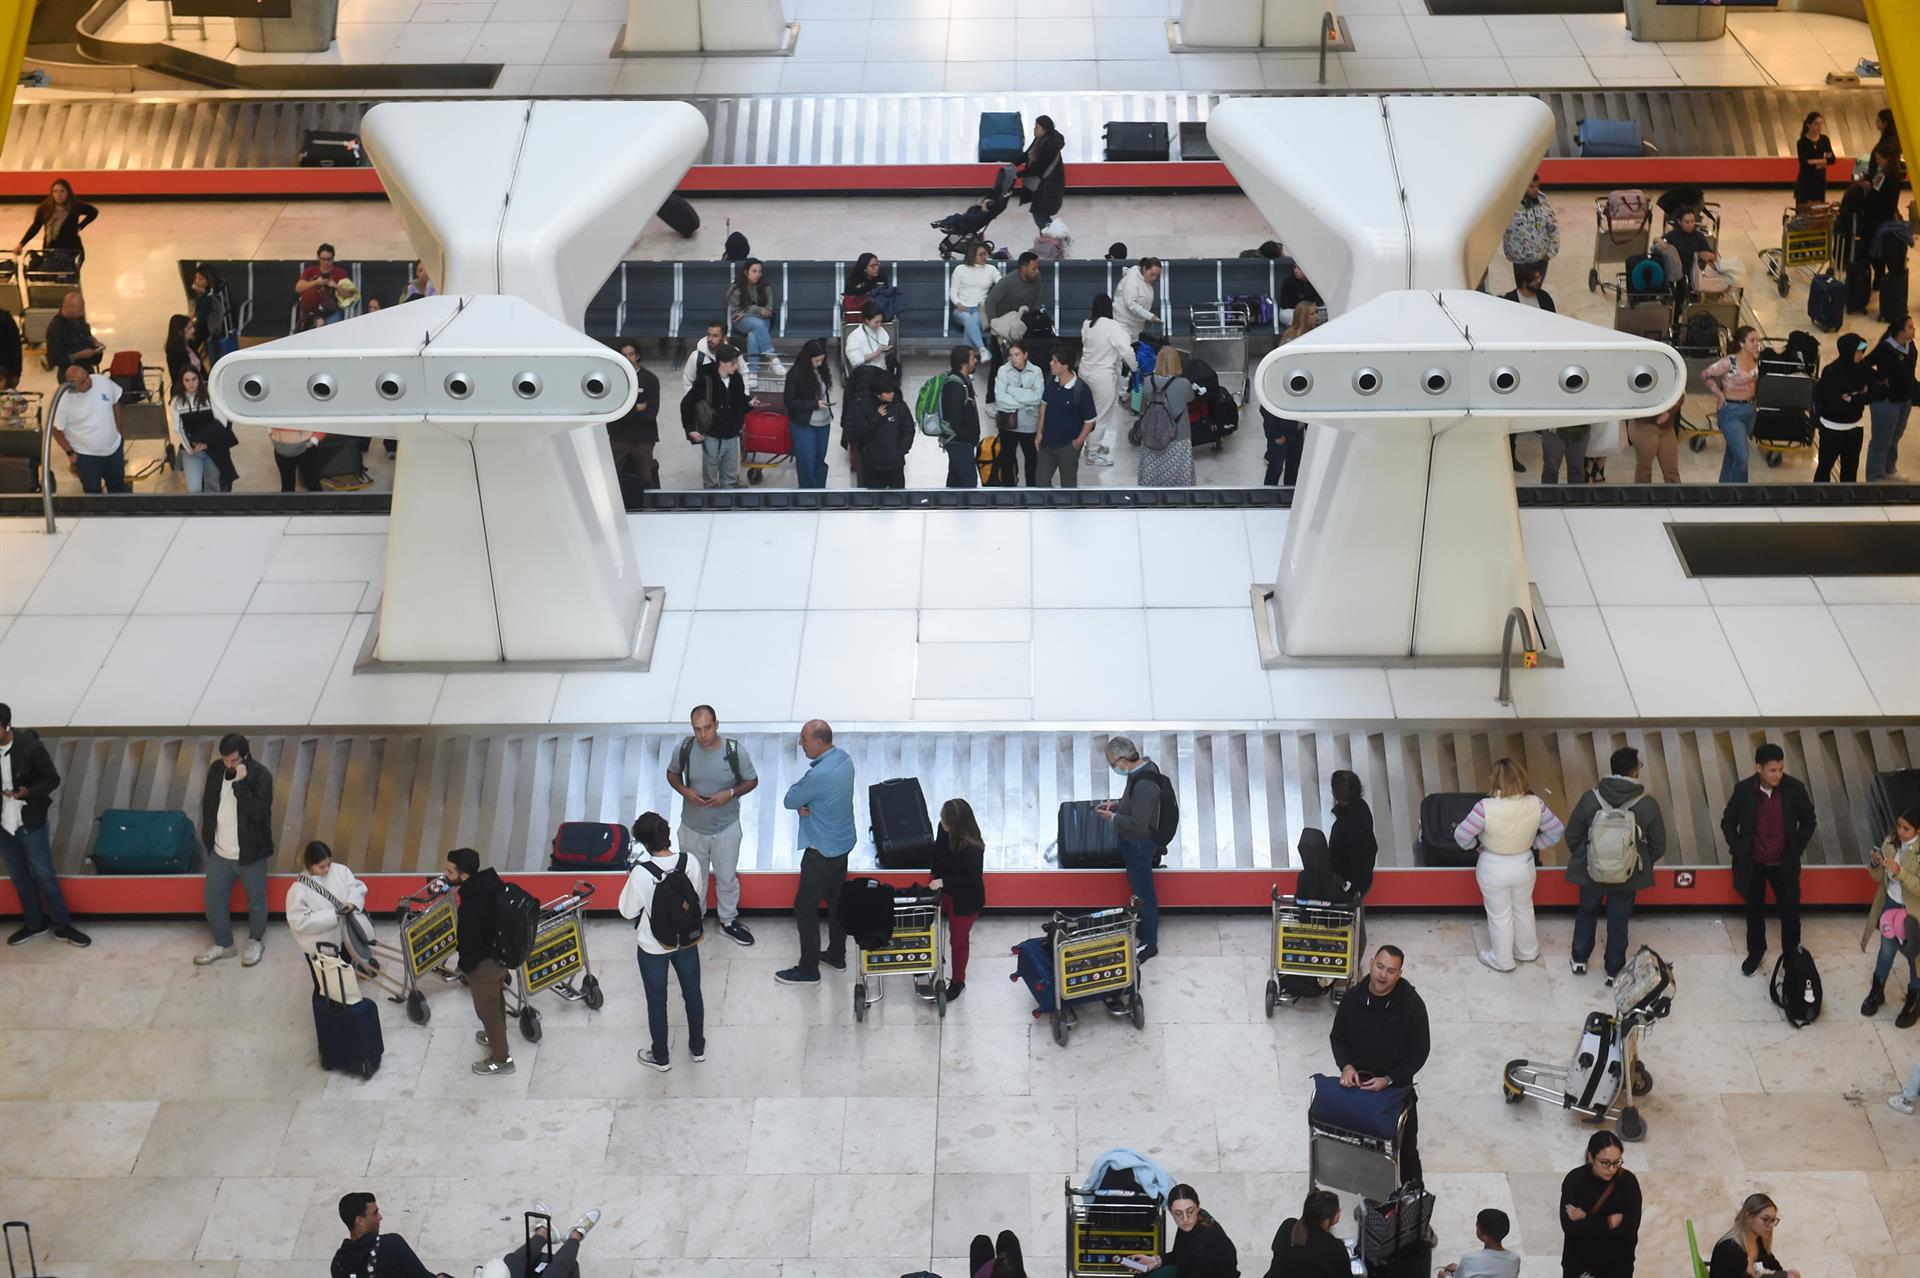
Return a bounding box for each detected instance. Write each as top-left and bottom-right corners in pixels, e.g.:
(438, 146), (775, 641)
(1567, 746), (1667, 984)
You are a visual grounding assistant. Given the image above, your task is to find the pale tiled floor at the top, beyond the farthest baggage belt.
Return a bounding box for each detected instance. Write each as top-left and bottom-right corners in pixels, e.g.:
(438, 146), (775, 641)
(86, 0), (1874, 94)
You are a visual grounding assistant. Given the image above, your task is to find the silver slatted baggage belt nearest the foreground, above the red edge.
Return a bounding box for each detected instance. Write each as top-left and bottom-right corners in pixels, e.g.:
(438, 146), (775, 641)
(33, 722), (1920, 873)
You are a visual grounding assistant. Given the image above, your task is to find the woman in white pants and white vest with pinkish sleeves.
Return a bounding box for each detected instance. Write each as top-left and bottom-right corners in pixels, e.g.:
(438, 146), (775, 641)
(1453, 758), (1567, 971)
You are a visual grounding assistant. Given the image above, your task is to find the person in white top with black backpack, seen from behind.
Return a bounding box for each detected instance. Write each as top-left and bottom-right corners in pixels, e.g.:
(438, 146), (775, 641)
(620, 809), (710, 1075)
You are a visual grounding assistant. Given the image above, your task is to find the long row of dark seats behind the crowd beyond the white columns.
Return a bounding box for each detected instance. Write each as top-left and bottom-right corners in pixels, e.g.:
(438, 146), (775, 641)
(180, 257), (1283, 349)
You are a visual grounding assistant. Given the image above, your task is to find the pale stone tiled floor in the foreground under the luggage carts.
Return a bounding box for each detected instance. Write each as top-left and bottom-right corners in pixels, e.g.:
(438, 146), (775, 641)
(0, 913), (1920, 1278)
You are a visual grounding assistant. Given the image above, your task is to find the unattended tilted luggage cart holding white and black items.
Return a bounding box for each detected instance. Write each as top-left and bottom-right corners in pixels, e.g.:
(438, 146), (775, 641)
(1500, 946), (1674, 1140)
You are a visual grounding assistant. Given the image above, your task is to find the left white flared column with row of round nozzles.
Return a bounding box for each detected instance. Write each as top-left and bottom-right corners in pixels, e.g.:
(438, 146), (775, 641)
(213, 102), (707, 664)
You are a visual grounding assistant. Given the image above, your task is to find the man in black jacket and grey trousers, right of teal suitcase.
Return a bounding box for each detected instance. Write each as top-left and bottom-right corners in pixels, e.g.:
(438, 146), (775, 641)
(194, 733), (273, 967)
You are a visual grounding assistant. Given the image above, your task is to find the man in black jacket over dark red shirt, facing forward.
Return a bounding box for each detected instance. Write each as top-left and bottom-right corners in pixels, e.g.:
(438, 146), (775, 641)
(1720, 741), (1814, 977)
